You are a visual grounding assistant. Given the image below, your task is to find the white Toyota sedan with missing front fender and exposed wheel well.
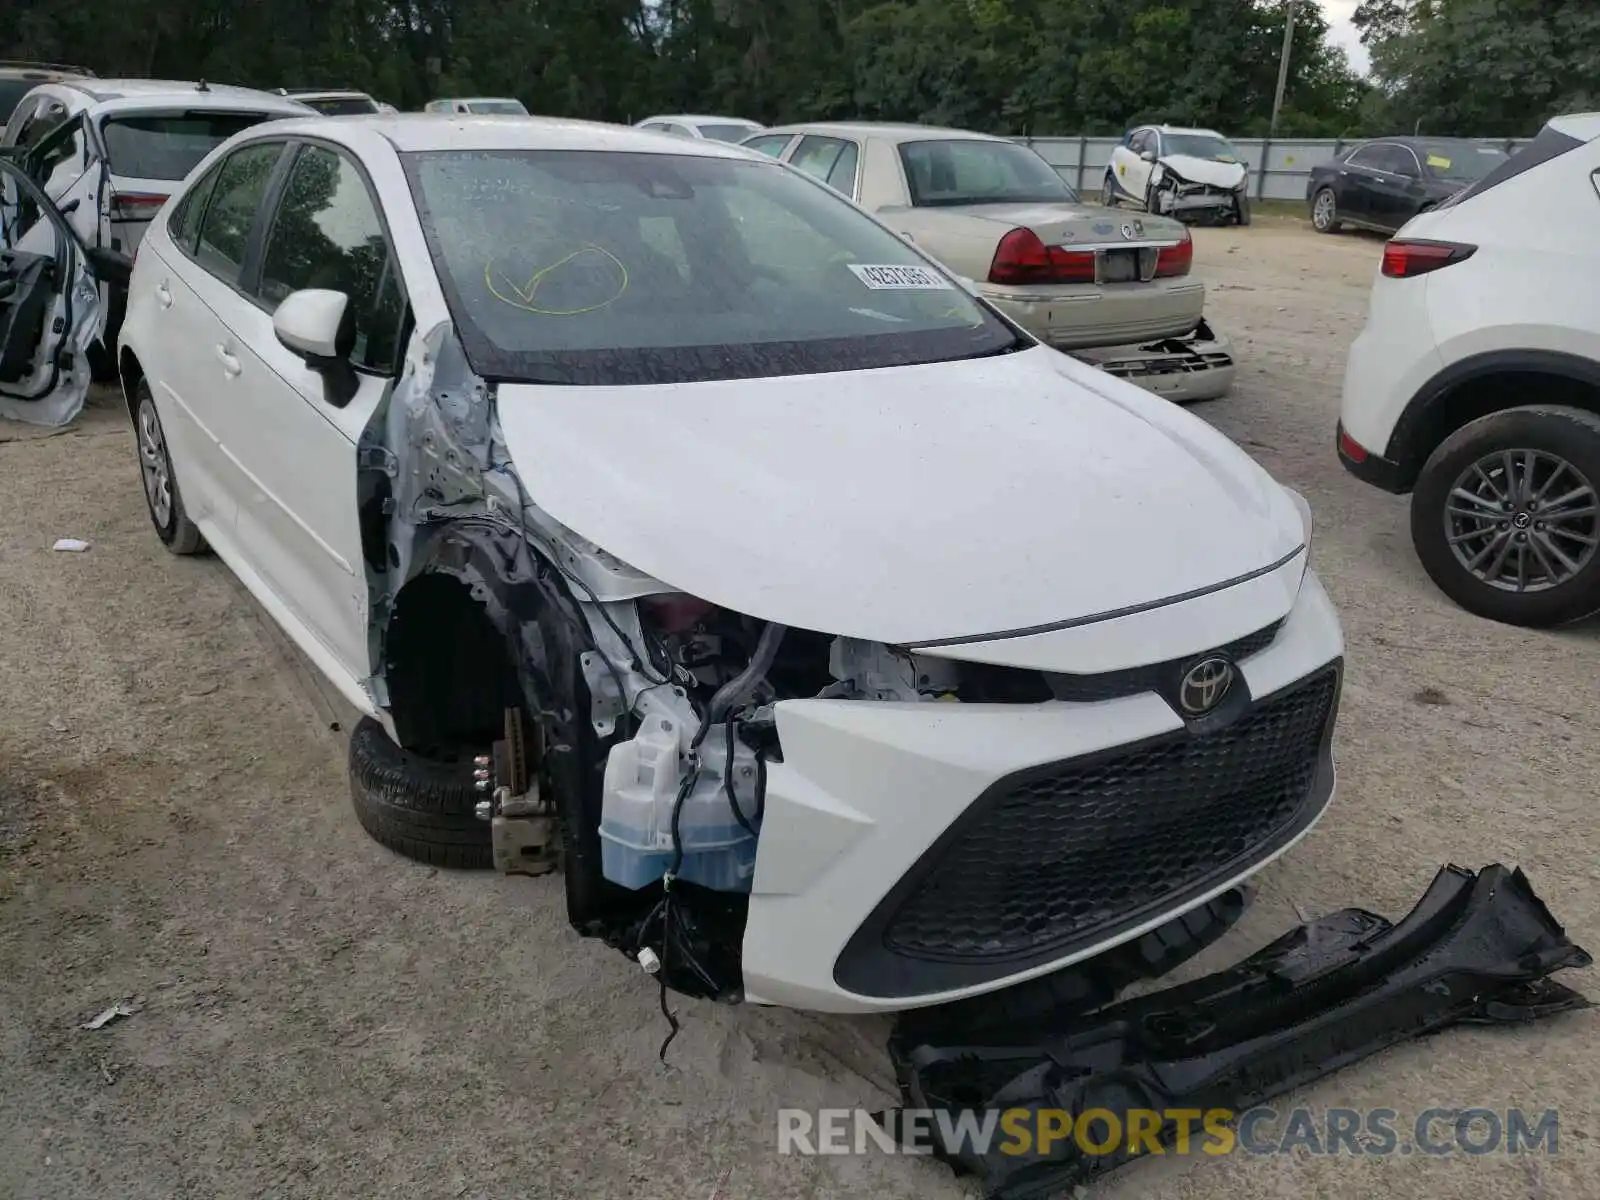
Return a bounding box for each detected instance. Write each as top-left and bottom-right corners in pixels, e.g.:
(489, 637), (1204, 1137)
(122, 117), (1344, 1011)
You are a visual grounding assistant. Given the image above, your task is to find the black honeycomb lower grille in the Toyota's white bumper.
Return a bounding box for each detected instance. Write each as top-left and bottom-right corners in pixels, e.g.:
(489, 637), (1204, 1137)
(883, 667), (1339, 962)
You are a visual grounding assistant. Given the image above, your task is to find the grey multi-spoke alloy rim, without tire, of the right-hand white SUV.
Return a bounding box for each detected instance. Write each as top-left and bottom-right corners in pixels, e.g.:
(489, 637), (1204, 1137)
(1445, 450), (1600, 592)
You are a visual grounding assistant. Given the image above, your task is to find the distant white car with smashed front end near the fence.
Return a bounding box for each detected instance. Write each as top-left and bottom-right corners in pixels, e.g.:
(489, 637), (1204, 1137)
(1101, 125), (1250, 226)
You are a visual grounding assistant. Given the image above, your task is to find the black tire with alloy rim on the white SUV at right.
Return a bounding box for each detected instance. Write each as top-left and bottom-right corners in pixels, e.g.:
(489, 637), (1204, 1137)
(1411, 405), (1600, 629)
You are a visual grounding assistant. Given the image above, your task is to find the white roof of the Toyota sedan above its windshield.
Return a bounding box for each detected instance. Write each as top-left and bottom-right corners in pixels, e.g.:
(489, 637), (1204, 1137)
(251, 112), (760, 160)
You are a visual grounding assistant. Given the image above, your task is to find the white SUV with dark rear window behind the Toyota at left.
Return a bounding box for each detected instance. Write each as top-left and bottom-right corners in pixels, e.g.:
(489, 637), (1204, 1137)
(0, 78), (314, 379)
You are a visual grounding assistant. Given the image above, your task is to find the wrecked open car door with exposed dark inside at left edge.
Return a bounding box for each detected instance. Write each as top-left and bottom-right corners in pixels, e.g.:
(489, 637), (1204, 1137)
(0, 157), (124, 426)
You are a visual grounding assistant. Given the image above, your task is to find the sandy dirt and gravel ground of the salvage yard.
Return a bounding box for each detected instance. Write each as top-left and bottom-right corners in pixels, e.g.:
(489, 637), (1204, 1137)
(0, 219), (1600, 1200)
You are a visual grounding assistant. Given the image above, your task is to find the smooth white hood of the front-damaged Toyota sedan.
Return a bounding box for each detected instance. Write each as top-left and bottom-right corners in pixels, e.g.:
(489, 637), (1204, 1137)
(498, 347), (1304, 645)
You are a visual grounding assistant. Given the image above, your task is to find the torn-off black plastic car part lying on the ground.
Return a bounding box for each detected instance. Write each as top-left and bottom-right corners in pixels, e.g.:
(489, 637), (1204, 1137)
(883, 864), (1592, 1200)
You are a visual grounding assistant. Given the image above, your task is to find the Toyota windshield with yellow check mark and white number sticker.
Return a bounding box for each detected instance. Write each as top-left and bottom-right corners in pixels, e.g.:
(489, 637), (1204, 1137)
(405, 150), (1026, 386)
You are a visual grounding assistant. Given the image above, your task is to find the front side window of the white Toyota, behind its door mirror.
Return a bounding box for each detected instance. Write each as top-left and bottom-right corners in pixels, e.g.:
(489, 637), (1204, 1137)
(258, 146), (400, 370)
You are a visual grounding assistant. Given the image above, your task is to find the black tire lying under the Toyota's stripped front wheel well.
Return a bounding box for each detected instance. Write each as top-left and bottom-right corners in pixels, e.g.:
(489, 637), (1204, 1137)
(350, 717), (494, 869)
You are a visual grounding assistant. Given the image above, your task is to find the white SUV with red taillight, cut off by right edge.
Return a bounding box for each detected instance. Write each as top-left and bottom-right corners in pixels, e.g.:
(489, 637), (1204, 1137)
(1338, 114), (1600, 626)
